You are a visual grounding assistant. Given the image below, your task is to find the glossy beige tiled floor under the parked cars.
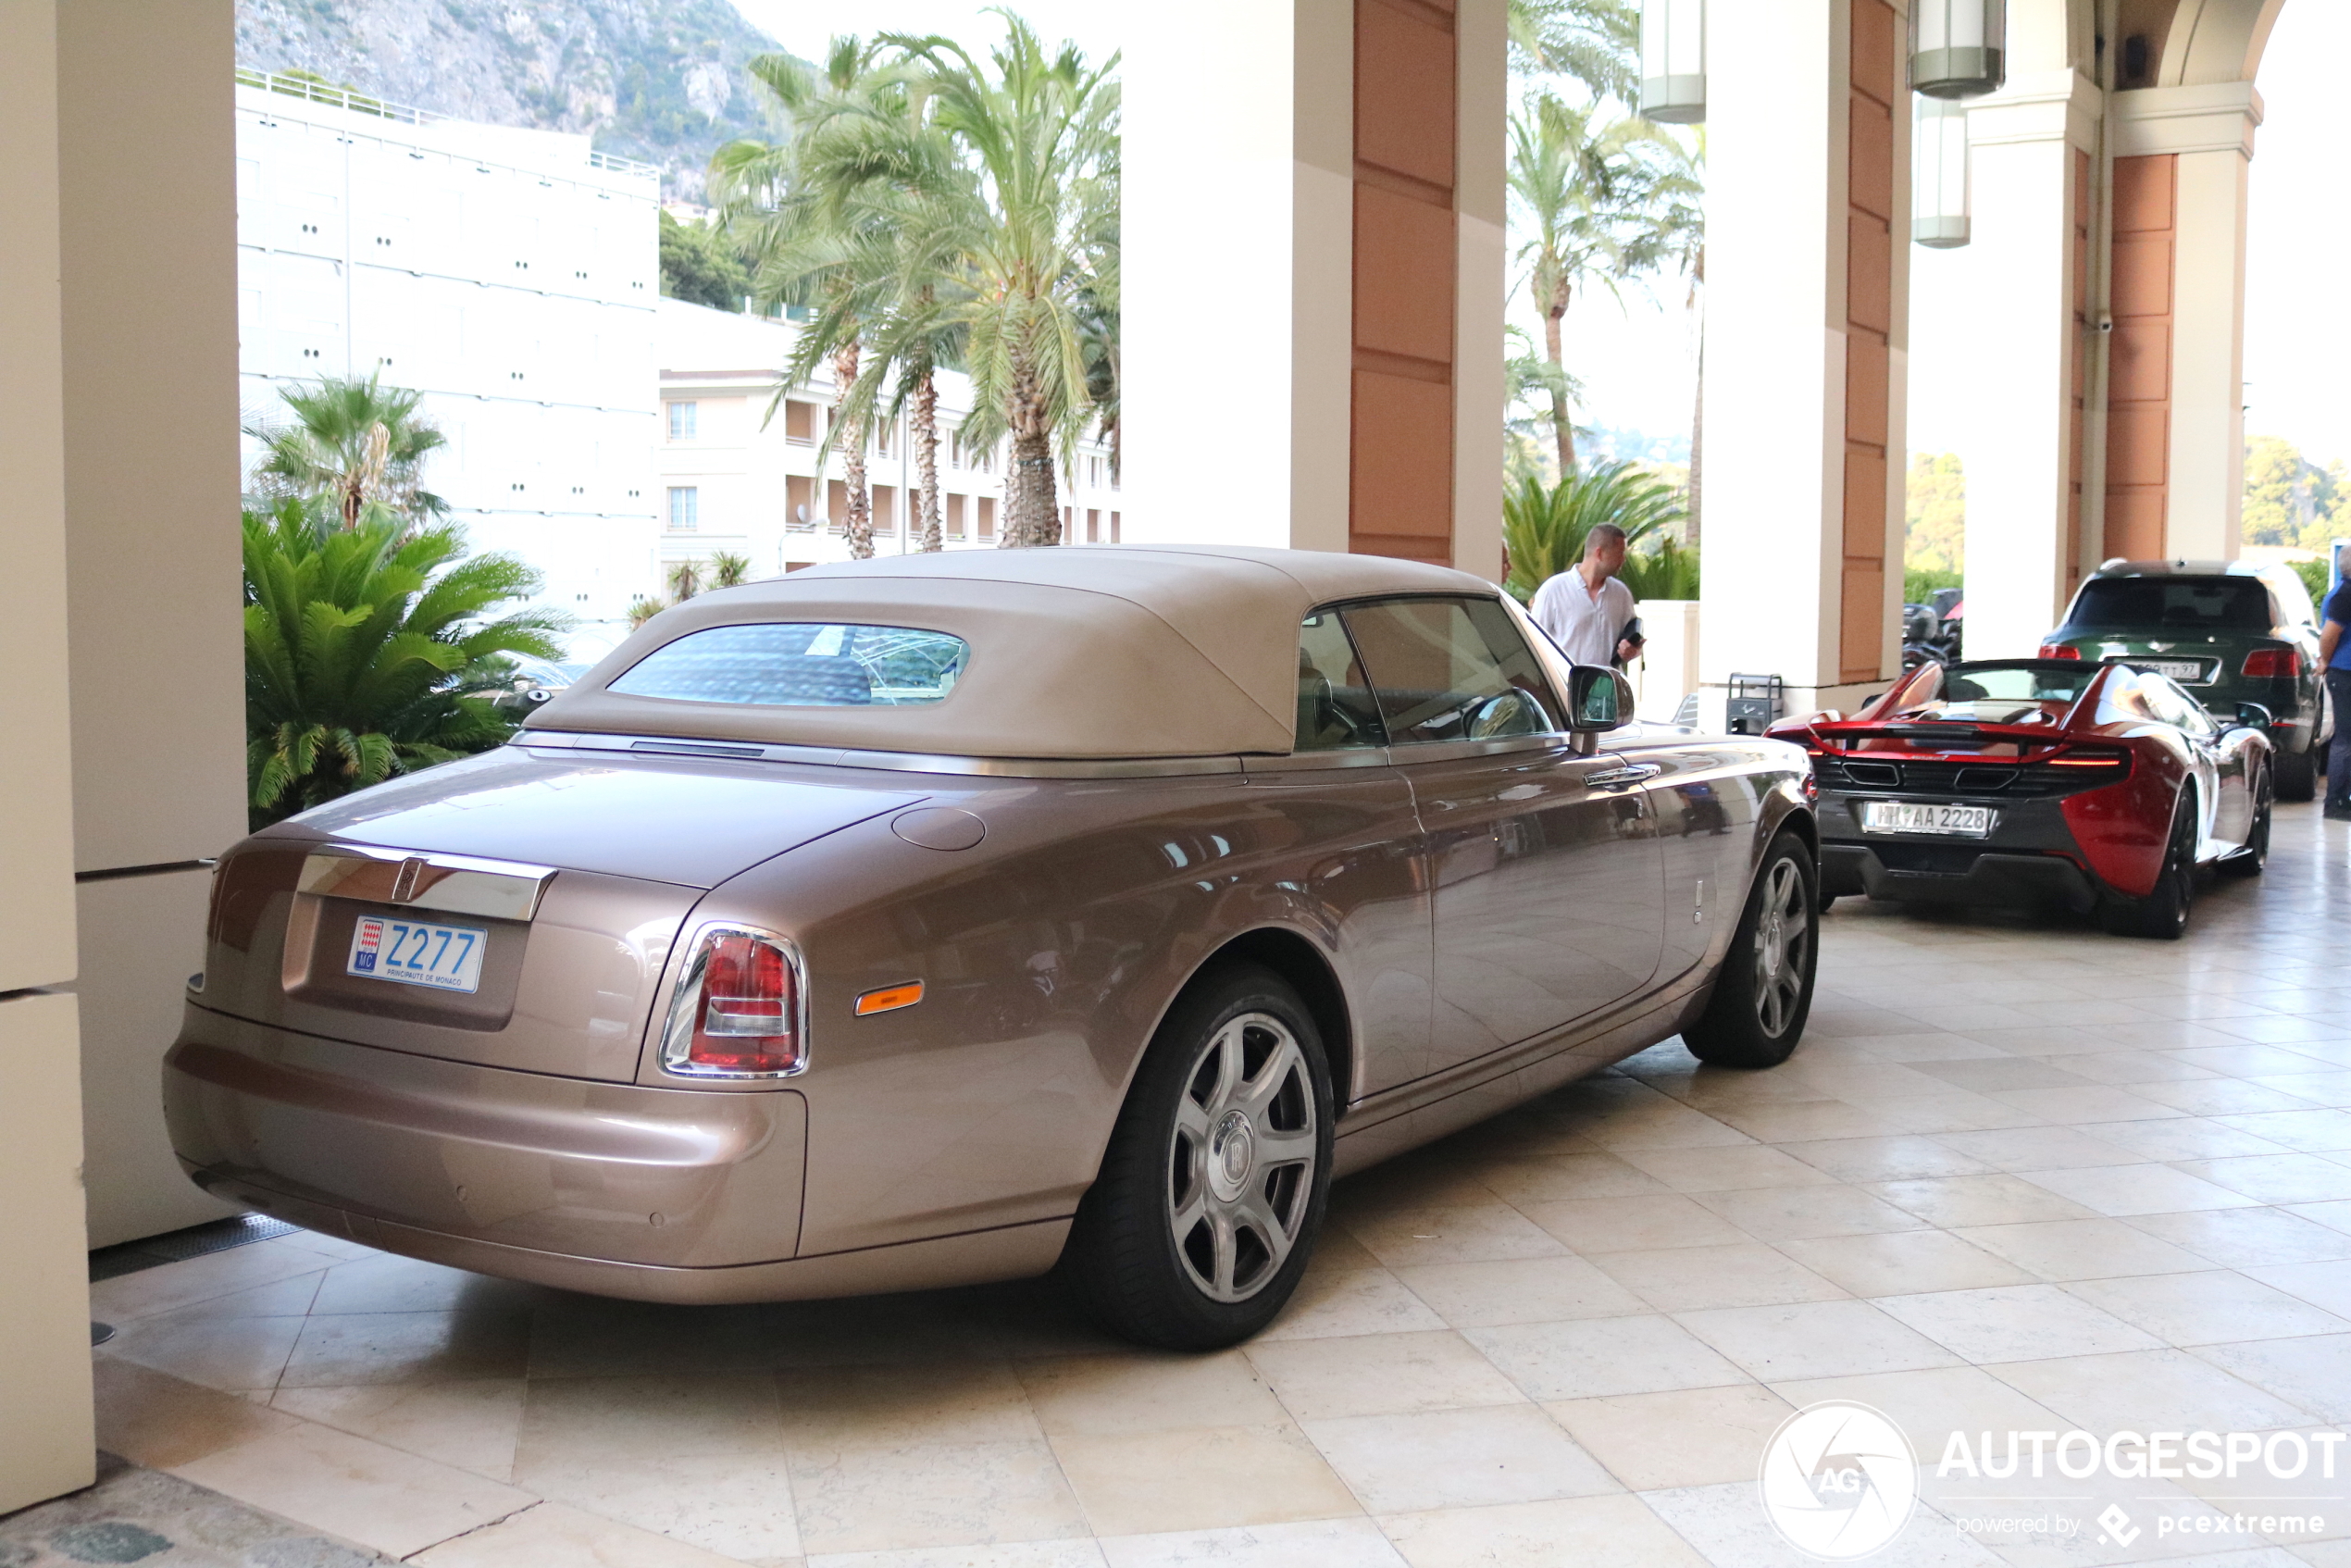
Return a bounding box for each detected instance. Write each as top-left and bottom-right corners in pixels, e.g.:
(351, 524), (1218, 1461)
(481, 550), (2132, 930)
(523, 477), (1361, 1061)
(78, 806), (2351, 1568)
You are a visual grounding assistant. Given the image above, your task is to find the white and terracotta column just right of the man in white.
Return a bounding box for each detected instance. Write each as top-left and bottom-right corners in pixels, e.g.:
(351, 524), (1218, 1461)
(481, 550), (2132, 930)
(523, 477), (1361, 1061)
(1699, 0), (1909, 722)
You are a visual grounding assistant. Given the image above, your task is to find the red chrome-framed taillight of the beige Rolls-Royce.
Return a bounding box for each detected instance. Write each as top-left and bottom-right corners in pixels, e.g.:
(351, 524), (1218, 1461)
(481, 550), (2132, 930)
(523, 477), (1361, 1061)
(661, 927), (809, 1079)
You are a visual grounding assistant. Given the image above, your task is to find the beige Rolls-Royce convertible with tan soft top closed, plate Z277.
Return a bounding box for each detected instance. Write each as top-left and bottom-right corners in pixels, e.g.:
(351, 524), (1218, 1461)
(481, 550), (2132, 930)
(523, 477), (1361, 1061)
(165, 545), (1817, 1347)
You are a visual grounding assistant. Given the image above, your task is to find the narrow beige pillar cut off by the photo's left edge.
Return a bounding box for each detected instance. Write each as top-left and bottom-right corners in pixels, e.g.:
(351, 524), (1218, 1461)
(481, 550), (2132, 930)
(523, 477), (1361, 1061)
(0, 5), (98, 1514)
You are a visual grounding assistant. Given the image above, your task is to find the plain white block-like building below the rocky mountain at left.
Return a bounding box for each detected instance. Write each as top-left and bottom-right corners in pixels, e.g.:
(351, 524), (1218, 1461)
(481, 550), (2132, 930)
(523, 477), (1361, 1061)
(238, 70), (661, 652)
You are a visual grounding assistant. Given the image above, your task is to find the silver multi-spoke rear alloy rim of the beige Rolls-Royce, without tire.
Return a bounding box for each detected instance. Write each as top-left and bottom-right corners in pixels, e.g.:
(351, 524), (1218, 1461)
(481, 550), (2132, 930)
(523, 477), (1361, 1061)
(1166, 1014), (1319, 1302)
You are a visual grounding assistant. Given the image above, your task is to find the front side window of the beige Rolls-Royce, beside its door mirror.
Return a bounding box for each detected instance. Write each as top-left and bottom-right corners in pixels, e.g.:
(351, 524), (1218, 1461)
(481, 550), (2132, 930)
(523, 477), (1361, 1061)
(1345, 600), (1561, 745)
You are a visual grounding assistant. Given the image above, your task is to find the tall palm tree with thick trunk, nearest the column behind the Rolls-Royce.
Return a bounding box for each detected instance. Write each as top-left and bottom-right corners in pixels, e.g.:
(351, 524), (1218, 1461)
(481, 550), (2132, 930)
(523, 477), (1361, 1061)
(884, 9), (1119, 545)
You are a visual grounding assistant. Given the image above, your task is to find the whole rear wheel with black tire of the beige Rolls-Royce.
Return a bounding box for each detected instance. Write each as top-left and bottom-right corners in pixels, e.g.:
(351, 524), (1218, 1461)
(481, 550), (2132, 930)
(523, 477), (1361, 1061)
(1063, 964), (1331, 1351)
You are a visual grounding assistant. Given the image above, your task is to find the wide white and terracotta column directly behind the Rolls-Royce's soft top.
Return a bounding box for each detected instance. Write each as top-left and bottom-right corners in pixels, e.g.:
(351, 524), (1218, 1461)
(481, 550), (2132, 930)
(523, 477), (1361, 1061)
(1122, 0), (1505, 576)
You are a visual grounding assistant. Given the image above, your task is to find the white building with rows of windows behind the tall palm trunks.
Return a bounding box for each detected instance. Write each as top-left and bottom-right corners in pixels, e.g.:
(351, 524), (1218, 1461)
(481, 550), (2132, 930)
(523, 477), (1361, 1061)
(656, 299), (1126, 579)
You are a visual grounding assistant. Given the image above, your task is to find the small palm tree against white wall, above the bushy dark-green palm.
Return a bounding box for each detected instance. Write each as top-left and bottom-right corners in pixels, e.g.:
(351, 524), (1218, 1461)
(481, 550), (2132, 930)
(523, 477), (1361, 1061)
(244, 376), (449, 529)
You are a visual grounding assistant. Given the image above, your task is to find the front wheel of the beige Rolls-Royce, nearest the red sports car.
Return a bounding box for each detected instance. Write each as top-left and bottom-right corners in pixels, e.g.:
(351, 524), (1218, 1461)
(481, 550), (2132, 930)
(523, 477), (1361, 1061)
(1681, 832), (1820, 1067)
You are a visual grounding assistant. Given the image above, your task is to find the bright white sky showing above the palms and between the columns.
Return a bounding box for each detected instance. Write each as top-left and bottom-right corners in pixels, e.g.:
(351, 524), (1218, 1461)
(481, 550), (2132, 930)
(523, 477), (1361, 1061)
(736, 0), (2351, 463)
